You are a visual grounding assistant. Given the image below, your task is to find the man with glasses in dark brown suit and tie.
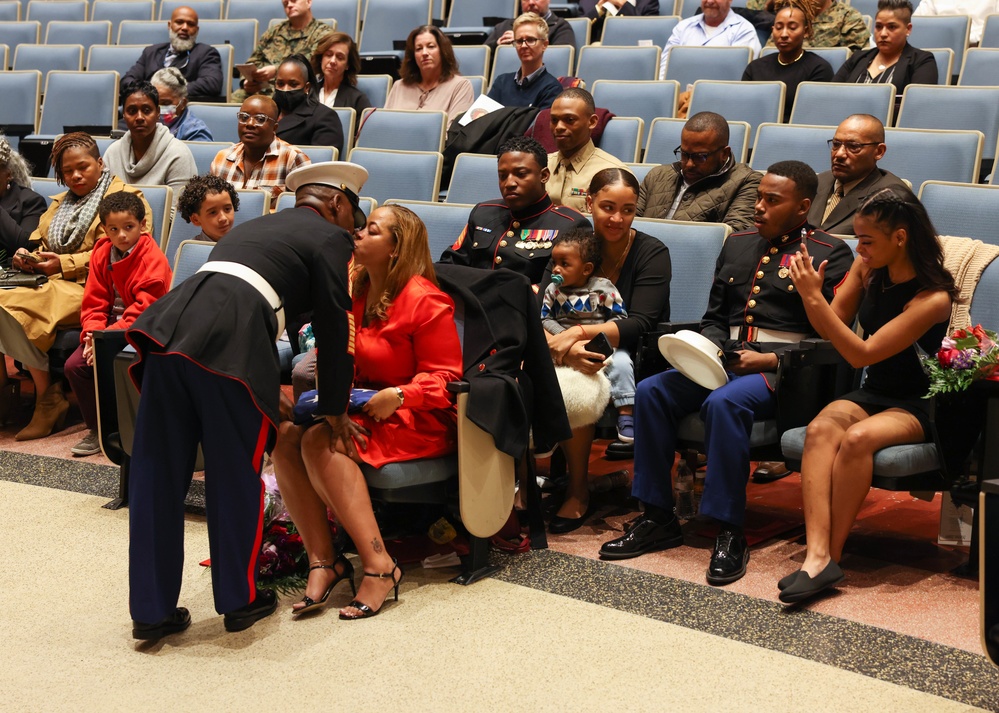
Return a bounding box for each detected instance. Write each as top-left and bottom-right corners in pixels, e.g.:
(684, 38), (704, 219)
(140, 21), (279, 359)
(808, 114), (903, 235)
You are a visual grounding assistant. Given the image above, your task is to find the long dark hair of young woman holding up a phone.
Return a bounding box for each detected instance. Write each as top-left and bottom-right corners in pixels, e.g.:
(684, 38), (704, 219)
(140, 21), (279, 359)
(857, 186), (961, 301)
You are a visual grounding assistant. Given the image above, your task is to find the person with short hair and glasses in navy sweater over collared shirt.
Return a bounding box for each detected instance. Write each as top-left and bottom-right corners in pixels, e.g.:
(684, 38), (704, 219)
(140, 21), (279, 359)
(489, 12), (562, 109)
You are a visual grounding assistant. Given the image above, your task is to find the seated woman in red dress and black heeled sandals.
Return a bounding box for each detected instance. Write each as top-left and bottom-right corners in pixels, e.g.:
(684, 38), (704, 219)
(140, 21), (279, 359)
(273, 205), (462, 619)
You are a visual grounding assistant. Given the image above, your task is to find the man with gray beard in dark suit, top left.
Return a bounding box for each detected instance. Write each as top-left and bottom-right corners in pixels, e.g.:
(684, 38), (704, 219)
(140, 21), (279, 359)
(121, 7), (225, 101)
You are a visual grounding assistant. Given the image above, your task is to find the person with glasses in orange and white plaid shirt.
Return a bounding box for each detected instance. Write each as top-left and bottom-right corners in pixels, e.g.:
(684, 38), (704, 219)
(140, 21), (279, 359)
(214, 94), (311, 198)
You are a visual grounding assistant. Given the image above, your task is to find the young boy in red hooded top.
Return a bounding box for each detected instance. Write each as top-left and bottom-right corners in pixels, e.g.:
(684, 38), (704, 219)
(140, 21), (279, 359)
(65, 191), (171, 456)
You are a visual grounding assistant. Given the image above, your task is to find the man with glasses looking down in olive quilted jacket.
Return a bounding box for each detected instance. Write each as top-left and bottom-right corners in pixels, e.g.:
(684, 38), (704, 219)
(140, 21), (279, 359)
(638, 111), (760, 232)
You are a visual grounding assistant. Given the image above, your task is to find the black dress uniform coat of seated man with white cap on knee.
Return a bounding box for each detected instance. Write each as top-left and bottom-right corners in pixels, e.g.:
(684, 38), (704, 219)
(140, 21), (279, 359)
(701, 223), (853, 389)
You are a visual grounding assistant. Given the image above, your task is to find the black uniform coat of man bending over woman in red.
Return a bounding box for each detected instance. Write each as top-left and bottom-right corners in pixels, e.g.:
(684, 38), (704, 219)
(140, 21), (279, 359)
(127, 208), (354, 426)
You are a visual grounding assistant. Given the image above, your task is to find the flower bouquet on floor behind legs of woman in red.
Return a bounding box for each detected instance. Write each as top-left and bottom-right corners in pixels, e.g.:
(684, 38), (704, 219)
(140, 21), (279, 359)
(257, 472), (337, 594)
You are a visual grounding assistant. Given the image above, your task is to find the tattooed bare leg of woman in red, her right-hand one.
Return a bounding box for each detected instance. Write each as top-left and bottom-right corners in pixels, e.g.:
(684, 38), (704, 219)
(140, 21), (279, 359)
(302, 424), (398, 616)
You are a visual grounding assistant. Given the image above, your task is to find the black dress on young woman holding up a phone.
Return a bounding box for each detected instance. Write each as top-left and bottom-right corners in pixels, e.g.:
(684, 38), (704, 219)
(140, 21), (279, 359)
(842, 271), (947, 441)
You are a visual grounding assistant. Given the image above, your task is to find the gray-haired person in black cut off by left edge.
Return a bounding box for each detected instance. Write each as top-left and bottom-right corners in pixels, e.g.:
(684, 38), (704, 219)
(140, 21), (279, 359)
(0, 133), (48, 264)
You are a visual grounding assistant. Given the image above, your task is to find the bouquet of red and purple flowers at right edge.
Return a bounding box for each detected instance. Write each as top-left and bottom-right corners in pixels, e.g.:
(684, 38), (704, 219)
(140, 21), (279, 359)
(923, 324), (999, 399)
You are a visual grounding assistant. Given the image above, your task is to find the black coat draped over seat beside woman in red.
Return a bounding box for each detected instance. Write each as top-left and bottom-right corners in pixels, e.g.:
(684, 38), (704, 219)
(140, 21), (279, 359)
(434, 263), (572, 458)
